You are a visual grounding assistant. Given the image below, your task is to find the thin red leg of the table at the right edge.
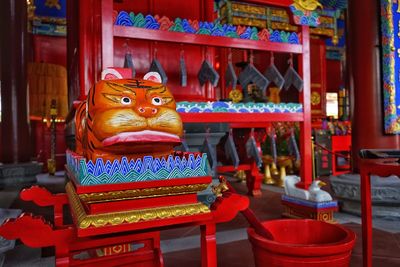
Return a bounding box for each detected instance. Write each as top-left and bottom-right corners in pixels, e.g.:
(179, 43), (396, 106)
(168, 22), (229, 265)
(360, 169), (372, 267)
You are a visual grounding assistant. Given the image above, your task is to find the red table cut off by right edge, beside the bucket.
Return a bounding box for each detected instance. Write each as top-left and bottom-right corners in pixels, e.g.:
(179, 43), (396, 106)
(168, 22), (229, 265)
(360, 158), (400, 267)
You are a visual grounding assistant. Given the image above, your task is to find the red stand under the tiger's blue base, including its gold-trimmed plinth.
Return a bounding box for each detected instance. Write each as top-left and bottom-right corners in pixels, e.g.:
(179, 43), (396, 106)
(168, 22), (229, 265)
(0, 178), (249, 266)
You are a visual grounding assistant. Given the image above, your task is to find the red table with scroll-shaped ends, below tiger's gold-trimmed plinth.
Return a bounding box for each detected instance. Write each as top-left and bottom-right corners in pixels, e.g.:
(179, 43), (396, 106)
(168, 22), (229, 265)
(0, 186), (249, 267)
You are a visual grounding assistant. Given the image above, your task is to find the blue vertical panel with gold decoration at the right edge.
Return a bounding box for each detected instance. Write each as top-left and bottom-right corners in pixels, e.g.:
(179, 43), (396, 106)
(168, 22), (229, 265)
(381, 0), (400, 134)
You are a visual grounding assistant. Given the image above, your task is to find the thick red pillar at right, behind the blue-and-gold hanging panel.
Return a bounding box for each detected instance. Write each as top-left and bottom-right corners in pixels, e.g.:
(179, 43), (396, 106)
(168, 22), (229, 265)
(347, 0), (400, 172)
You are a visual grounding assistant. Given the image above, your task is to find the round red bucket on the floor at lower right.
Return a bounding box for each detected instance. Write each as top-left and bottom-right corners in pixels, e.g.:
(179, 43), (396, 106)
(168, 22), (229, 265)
(247, 219), (356, 267)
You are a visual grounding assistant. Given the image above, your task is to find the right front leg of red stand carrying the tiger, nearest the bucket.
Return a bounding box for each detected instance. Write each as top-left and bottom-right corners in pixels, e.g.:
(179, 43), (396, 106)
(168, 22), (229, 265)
(200, 223), (217, 267)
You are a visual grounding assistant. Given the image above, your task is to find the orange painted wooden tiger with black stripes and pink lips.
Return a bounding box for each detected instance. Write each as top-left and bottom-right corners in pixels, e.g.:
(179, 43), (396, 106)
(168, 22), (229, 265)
(75, 72), (183, 162)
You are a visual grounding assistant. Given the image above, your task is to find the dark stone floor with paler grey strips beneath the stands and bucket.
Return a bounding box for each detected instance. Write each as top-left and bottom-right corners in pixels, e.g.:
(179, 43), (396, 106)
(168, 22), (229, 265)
(0, 173), (400, 267)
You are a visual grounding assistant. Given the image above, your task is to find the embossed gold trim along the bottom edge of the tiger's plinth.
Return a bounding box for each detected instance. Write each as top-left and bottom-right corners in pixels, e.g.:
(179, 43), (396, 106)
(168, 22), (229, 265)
(65, 182), (210, 229)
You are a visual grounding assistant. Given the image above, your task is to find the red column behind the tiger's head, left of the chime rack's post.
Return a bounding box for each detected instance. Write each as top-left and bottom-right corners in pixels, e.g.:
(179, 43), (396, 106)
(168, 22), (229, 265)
(67, 0), (104, 101)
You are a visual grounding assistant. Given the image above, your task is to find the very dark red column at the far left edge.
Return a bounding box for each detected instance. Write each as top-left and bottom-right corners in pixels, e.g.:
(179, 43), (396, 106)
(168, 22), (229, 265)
(0, 0), (31, 163)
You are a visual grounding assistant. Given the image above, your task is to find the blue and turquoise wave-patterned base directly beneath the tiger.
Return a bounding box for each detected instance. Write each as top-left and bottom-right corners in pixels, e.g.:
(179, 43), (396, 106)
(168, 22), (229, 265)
(67, 151), (208, 185)
